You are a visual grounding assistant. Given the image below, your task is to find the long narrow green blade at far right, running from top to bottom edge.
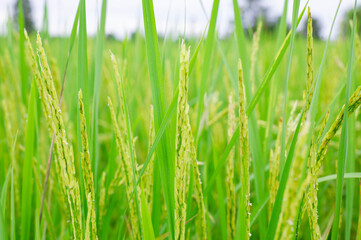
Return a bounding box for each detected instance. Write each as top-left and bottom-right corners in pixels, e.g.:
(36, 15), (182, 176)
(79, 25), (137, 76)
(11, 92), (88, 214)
(331, 0), (357, 240)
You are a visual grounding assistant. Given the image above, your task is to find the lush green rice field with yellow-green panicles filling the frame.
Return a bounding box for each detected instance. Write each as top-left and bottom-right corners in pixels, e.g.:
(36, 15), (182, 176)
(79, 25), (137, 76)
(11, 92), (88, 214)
(0, 0), (361, 240)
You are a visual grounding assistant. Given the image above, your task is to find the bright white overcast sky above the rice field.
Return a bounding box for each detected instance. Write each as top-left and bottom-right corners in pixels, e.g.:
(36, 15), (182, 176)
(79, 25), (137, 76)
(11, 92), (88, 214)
(0, 0), (354, 38)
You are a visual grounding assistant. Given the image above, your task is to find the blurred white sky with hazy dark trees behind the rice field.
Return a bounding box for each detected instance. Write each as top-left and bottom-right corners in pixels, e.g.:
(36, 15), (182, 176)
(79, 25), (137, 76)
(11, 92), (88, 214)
(0, 0), (361, 39)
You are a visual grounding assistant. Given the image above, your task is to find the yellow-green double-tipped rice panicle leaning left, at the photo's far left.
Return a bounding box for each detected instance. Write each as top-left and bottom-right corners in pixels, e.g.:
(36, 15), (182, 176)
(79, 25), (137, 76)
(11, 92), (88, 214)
(25, 31), (83, 239)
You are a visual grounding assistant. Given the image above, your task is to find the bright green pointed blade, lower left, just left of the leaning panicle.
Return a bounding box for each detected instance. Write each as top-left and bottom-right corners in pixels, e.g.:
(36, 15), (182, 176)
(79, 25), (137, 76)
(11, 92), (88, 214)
(21, 80), (36, 240)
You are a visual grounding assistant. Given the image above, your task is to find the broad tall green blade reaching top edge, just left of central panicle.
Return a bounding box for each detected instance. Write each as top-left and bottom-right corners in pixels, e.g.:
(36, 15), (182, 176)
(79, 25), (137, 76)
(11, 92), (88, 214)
(142, 0), (174, 236)
